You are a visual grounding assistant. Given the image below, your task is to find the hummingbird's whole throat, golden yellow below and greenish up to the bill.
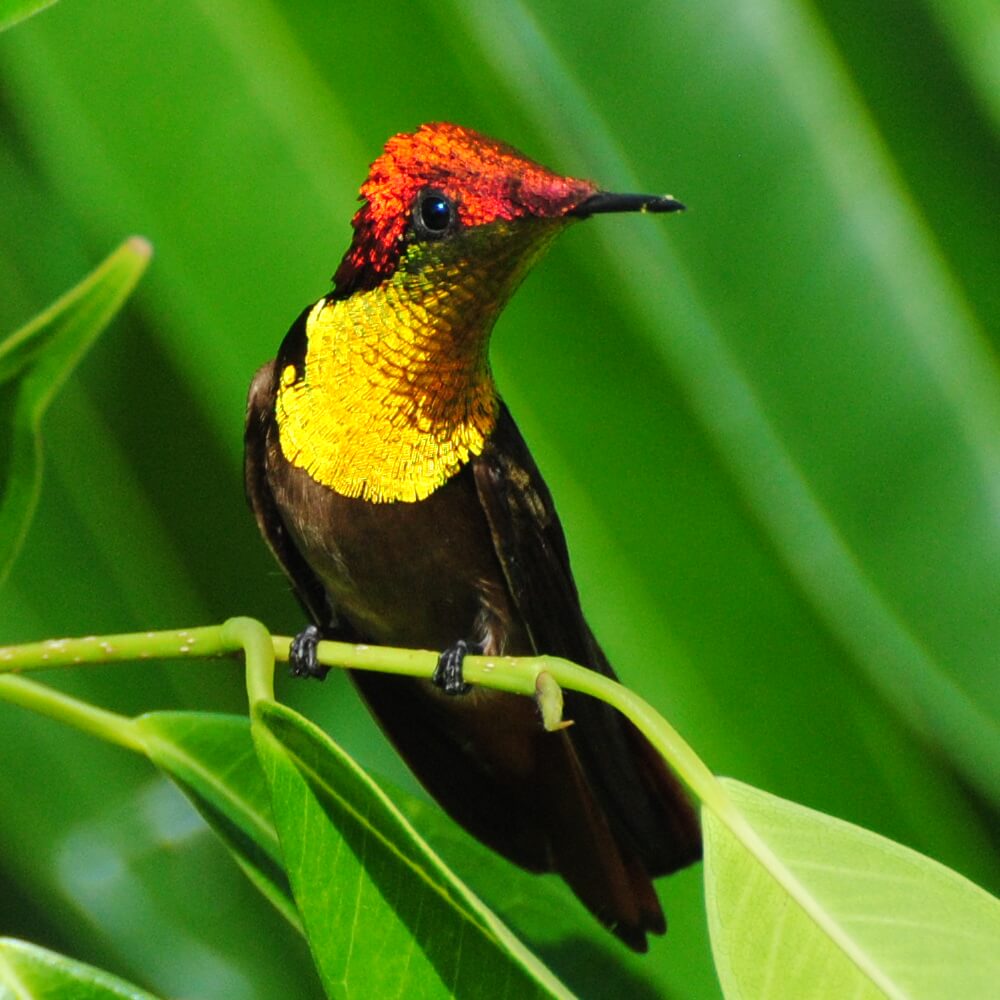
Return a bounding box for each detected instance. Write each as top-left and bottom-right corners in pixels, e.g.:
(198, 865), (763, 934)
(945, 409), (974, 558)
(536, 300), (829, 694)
(275, 218), (572, 503)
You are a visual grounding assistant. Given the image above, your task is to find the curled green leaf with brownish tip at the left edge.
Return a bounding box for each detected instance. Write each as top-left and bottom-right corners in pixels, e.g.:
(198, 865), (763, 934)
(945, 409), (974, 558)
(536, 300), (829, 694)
(0, 237), (152, 583)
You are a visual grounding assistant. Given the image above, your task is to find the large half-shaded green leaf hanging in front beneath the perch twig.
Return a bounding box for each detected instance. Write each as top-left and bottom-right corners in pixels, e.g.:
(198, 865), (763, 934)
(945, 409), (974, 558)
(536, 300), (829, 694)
(253, 702), (570, 998)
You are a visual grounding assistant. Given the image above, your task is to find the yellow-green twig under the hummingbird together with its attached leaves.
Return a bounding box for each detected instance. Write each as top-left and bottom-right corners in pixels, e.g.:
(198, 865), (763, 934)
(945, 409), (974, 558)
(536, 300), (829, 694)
(0, 618), (1000, 1000)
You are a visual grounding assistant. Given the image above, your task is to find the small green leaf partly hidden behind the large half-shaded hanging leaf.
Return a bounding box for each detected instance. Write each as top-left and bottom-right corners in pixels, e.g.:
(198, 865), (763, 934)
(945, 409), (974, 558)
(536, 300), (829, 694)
(135, 712), (302, 931)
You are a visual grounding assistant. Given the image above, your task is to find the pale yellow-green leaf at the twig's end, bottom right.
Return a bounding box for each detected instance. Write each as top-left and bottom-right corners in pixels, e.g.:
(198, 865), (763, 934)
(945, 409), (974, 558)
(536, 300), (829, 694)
(703, 779), (1000, 1000)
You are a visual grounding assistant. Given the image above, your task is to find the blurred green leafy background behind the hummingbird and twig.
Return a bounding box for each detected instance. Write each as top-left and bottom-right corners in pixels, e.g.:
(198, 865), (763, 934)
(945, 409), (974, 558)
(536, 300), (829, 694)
(0, 0), (1000, 998)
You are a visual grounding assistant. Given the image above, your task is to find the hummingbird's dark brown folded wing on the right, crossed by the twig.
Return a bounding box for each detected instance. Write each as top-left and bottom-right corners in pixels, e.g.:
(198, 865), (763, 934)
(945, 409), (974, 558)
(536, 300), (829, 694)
(473, 407), (701, 876)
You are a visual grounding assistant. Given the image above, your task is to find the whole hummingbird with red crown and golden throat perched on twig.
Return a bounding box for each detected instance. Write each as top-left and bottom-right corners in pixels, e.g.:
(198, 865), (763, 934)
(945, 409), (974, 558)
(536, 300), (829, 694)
(245, 122), (701, 951)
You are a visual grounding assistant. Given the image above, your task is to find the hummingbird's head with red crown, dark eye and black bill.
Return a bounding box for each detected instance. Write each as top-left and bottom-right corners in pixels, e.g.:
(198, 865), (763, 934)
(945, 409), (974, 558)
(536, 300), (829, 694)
(333, 122), (683, 305)
